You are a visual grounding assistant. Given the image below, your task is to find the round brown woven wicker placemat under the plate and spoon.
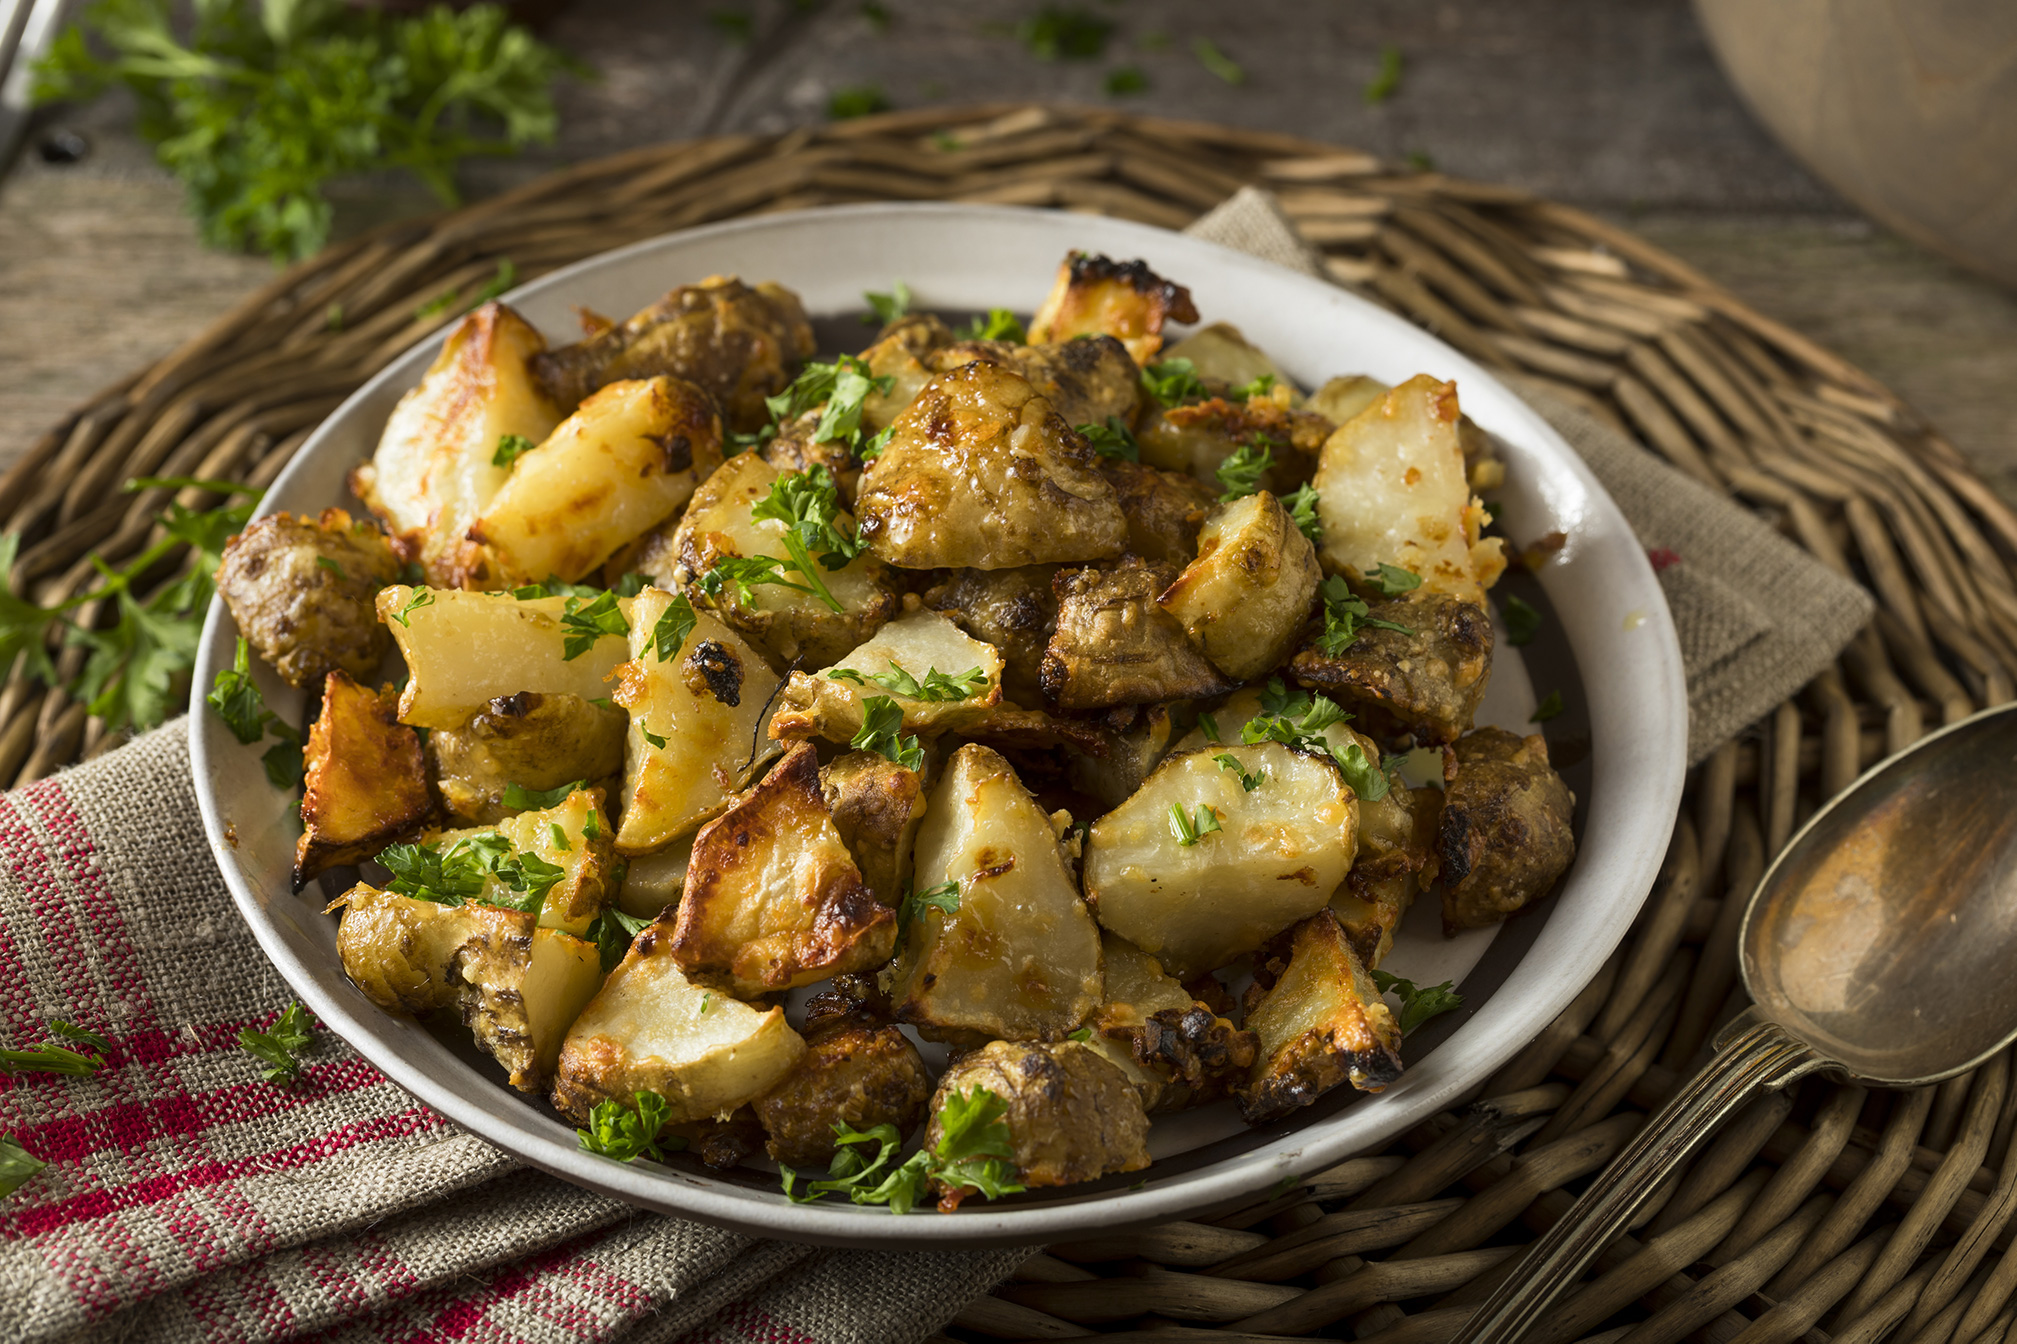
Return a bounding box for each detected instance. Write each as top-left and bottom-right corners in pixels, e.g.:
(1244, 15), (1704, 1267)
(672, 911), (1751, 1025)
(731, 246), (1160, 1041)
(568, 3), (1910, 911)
(15, 107), (2017, 1344)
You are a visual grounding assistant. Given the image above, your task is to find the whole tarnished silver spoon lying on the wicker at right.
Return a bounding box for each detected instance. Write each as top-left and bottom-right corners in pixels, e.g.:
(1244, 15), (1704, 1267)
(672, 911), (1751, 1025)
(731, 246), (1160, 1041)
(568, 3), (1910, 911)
(1452, 704), (2017, 1344)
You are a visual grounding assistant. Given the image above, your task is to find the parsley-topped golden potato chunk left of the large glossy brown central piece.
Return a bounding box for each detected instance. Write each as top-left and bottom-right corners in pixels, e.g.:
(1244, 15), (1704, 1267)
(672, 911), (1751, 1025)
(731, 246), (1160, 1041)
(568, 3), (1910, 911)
(672, 452), (898, 668)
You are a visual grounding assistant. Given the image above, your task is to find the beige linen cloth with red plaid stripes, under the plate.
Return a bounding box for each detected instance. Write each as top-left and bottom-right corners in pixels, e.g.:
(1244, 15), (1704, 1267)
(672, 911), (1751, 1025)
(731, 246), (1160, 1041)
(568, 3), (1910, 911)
(0, 183), (1870, 1344)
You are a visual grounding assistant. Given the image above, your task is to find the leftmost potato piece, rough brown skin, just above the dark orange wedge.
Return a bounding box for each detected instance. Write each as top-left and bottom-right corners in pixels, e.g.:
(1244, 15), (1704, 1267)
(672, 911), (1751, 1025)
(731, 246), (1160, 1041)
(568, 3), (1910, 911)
(218, 509), (399, 690)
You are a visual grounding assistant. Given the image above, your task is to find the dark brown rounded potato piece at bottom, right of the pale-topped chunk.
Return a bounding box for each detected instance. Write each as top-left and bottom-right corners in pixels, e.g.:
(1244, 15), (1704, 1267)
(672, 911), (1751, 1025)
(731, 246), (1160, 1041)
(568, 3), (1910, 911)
(756, 1013), (932, 1166)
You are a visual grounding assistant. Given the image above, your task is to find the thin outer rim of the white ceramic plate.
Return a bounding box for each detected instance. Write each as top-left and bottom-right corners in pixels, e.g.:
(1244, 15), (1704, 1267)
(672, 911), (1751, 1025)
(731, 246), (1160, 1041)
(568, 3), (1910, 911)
(190, 202), (1688, 1249)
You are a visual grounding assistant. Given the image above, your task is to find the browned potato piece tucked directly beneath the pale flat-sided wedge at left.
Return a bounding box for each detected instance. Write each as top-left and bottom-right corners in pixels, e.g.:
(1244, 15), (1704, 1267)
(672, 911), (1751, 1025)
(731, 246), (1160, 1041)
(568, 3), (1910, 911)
(428, 690), (629, 825)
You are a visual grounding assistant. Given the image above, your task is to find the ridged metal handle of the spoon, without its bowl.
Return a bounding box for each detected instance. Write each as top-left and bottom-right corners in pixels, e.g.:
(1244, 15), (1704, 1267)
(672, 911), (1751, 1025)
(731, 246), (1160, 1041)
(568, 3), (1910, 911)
(1450, 1019), (1825, 1344)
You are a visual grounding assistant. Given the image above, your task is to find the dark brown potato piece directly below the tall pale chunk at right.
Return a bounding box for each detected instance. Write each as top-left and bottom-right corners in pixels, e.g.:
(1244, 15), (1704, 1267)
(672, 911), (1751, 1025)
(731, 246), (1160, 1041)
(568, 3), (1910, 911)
(1289, 589), (1493, 747)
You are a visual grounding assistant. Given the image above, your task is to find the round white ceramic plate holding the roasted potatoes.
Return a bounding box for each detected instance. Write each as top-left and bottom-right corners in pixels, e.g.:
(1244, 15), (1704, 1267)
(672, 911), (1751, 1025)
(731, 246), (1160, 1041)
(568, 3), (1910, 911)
(190, 204), (1686, 1247)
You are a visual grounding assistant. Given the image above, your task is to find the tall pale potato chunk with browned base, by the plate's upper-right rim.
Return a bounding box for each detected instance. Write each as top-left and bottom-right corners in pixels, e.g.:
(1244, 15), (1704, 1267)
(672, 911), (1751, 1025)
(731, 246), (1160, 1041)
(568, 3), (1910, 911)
(1313, 373), (1505, 607)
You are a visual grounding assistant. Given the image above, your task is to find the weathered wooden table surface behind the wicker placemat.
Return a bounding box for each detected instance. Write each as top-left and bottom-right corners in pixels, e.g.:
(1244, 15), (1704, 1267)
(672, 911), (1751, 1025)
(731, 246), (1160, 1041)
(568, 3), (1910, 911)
(0, 0), (2017, 502)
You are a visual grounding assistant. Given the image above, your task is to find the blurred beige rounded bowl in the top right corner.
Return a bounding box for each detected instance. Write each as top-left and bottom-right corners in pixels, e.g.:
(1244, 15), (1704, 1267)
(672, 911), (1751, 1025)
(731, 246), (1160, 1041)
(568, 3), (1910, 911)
(1696, 0), (2017, 287)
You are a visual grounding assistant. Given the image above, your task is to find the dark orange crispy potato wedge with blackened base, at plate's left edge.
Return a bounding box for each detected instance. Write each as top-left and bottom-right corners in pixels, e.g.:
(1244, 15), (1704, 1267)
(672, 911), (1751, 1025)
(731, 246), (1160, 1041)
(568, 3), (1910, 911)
(294, 672), (434, 886)
